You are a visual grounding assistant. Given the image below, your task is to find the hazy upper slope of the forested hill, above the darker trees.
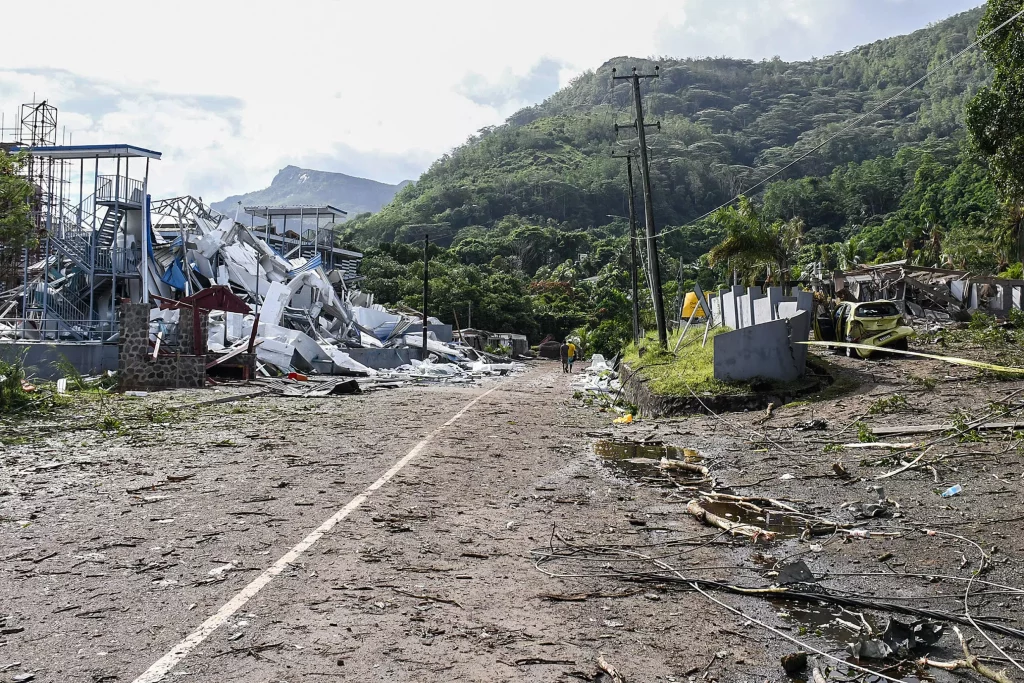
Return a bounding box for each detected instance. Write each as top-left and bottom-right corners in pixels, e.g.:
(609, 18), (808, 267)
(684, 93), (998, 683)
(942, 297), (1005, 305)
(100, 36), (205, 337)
(348, 8), (990, 253)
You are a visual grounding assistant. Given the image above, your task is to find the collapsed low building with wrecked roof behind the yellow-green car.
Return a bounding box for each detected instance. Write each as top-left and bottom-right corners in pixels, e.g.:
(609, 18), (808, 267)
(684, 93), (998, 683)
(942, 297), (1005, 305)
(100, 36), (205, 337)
(834, 261), (1024, 319)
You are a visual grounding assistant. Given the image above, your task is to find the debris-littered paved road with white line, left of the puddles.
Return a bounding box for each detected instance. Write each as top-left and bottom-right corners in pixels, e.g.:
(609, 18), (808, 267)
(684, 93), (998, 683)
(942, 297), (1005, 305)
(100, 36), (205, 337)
(6, 364), (712, 682)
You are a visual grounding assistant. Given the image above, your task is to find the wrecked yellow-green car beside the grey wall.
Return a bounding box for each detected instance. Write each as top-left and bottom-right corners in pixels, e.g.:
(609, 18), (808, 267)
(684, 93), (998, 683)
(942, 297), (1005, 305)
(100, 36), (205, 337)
(815, 301), (913, 358)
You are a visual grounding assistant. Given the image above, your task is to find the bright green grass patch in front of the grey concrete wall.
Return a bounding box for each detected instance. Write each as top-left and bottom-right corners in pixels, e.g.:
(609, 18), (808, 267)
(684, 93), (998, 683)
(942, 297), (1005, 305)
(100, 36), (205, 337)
(623, 327), (751, 396)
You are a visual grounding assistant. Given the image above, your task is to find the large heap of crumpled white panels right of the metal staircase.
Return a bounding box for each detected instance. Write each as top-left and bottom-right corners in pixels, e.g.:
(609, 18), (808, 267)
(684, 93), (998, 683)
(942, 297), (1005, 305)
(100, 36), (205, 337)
(151, 208), (517, 377)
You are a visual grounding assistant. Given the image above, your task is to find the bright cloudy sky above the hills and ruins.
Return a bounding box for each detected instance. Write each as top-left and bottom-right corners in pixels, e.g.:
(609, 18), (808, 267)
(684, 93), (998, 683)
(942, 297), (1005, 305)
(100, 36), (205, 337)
(0, 0), (981, 202)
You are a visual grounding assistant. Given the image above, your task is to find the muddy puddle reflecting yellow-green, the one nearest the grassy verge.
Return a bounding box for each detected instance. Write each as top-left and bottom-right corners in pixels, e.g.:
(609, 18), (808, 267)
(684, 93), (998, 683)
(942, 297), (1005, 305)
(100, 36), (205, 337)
(594, 440), (710, 488)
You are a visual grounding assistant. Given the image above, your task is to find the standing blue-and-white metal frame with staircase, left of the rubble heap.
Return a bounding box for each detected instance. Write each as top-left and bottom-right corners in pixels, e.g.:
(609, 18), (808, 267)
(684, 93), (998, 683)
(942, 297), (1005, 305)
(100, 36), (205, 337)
(0, 101), (161, 341)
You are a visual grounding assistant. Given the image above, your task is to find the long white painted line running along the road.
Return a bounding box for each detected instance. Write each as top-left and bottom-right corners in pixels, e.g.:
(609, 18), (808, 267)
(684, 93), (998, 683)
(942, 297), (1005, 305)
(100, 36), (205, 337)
(132, 387), (498, 683)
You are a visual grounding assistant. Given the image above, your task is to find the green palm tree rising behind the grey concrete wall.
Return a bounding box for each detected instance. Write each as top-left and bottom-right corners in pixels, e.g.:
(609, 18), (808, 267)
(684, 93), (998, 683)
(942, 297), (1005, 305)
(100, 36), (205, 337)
(708, 197), (804, 286)
